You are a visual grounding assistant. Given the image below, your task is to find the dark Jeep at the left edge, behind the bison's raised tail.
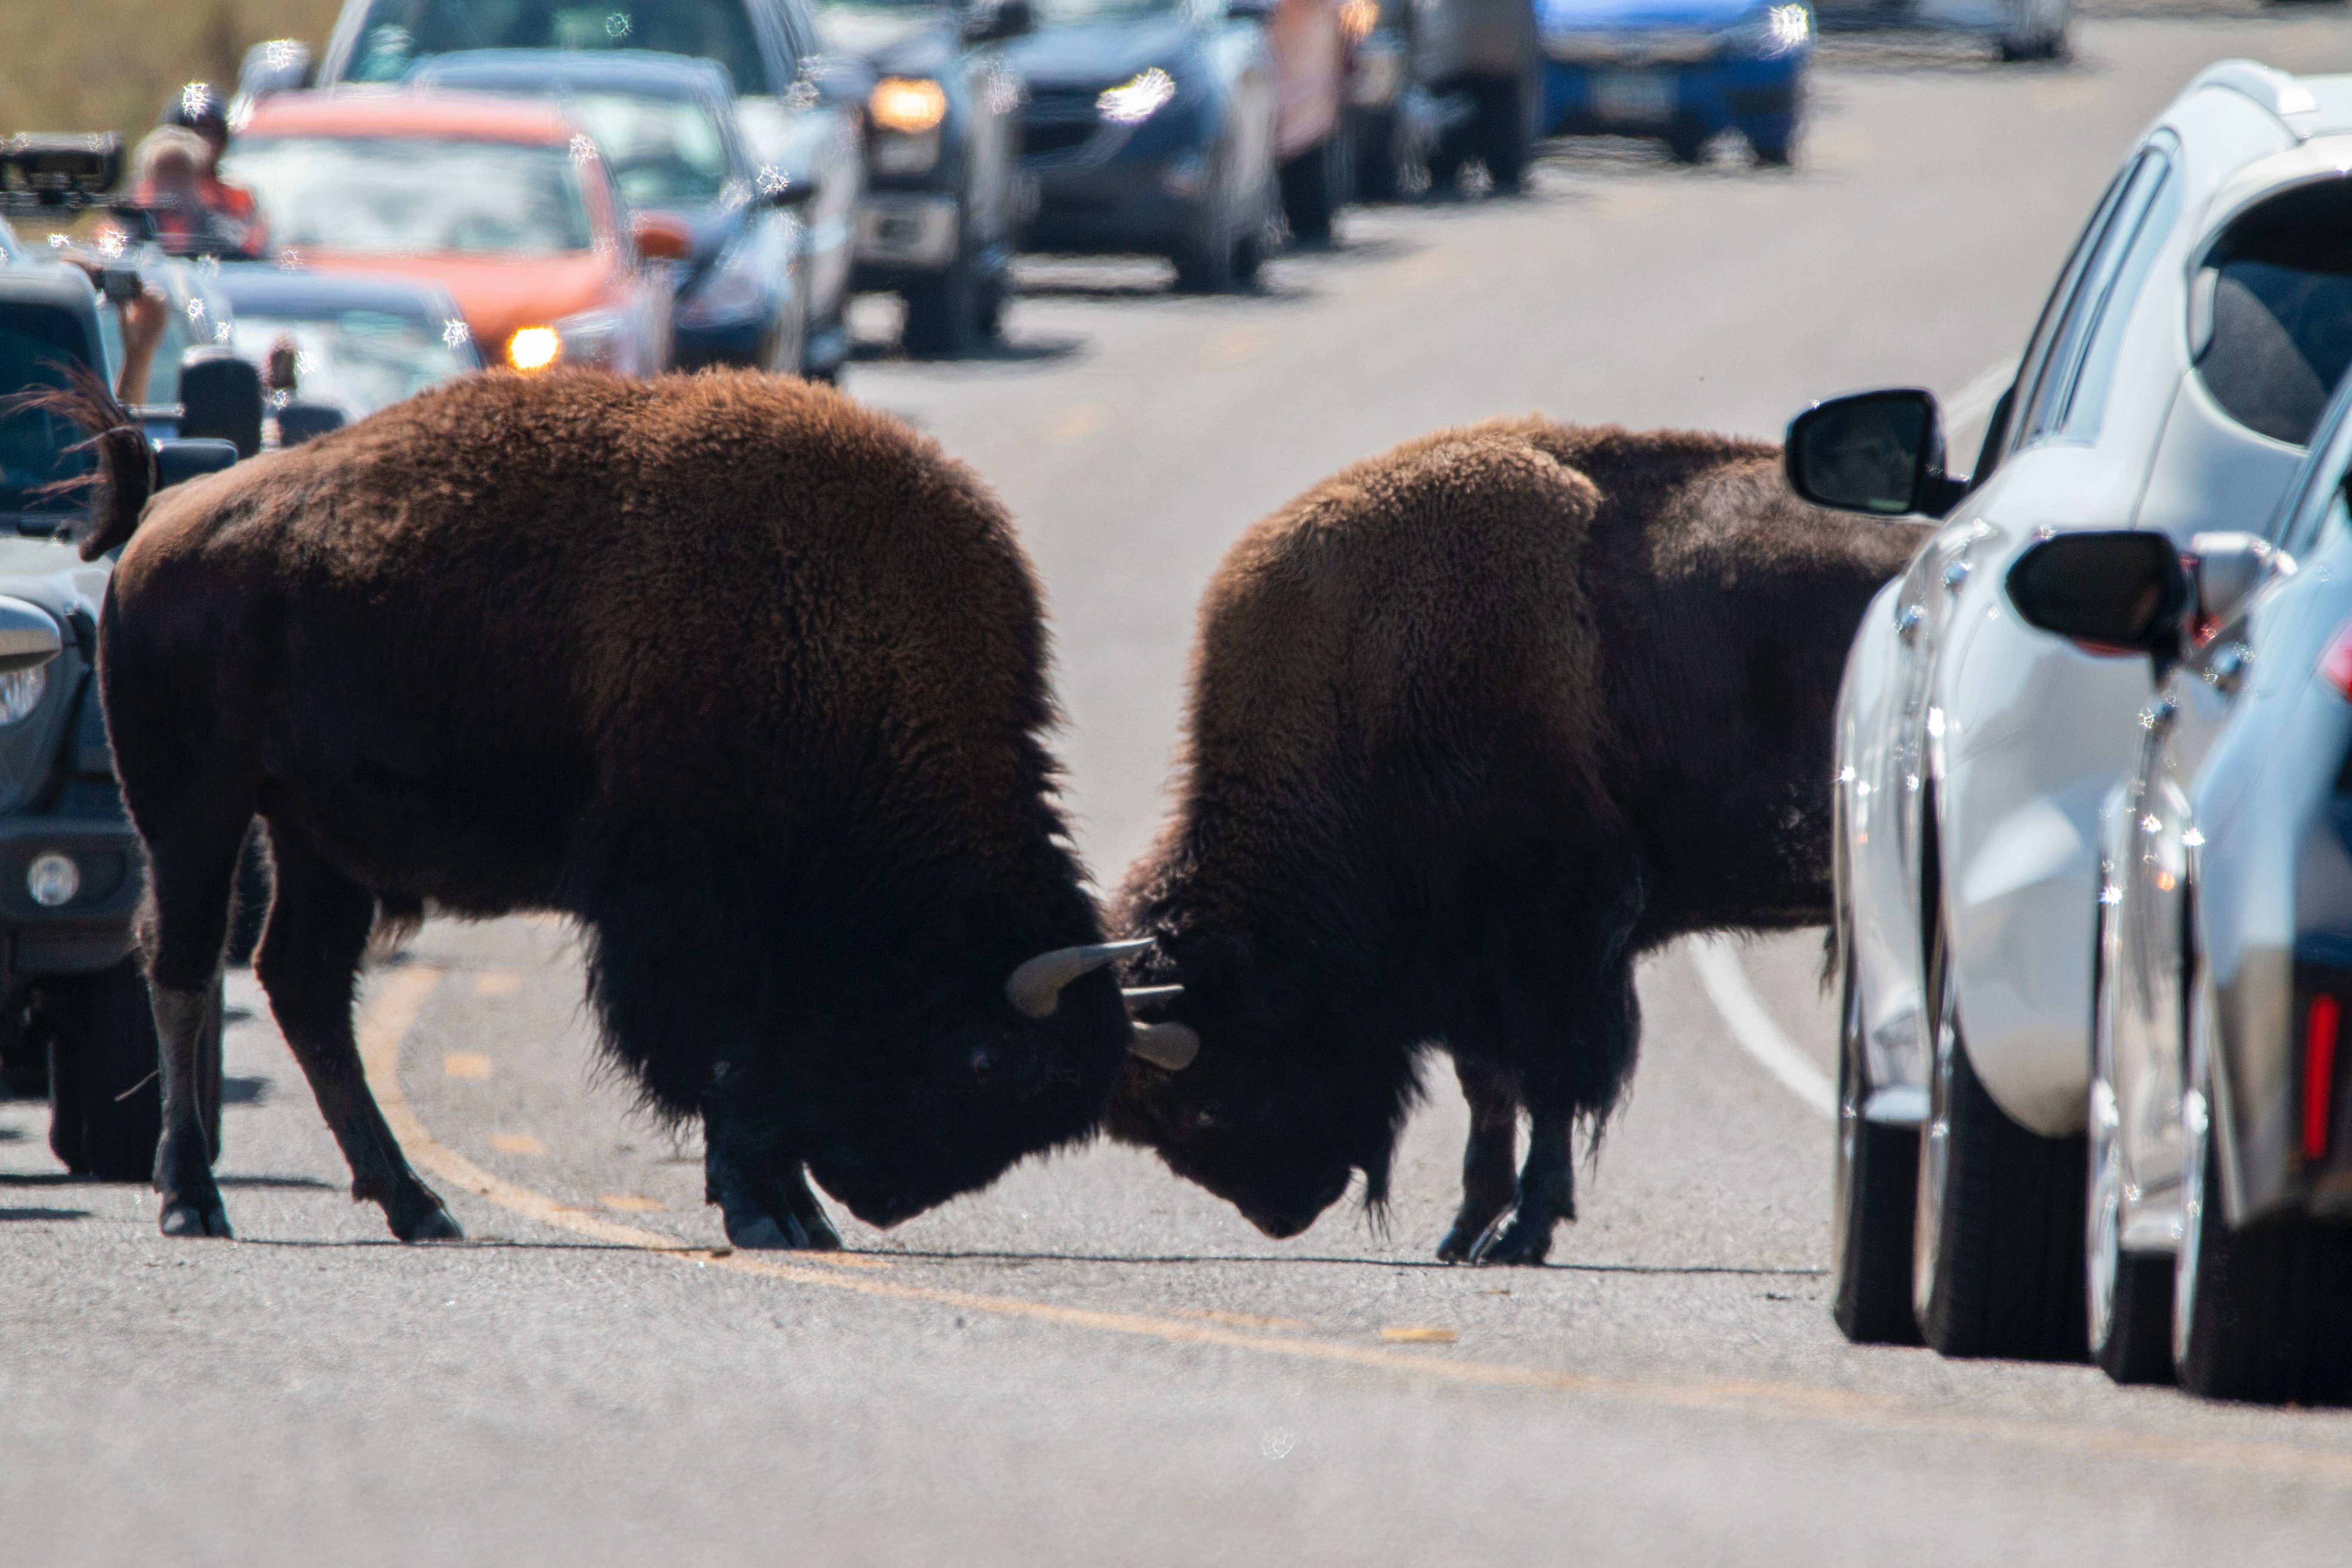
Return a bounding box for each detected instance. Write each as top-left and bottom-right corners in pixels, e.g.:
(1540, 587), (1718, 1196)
(0, 153), (248, 1180)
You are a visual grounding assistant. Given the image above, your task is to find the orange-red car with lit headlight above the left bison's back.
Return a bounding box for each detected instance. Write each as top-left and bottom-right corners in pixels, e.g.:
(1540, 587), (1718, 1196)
(221, 92), (692, 376)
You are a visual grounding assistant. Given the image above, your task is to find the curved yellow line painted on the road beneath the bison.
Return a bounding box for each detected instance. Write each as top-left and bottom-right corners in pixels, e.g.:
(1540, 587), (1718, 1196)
(360, 964), (2352, 1488)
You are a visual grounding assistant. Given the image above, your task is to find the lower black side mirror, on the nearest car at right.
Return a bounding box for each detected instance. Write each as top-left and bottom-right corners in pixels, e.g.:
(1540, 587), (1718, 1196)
(2009, 529), (2194, 661)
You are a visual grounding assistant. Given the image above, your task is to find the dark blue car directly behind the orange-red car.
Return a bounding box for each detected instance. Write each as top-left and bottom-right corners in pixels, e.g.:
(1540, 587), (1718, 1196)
(407, 49), (812, 374)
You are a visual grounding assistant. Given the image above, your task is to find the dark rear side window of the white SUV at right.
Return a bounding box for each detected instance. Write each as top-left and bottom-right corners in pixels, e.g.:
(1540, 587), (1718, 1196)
(2197, 179), (2352, 447)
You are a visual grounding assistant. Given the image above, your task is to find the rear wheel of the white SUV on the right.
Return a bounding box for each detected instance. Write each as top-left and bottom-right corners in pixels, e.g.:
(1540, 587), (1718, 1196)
(1912, 919), (2086, 1361)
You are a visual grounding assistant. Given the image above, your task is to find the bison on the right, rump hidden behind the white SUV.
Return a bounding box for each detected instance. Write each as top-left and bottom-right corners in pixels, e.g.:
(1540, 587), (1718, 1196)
(1110, 419), (1922, 1262)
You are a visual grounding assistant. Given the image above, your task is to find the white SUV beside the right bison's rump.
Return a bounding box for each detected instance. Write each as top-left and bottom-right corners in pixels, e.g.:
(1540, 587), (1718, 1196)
(1788, 61), (2352, 1357)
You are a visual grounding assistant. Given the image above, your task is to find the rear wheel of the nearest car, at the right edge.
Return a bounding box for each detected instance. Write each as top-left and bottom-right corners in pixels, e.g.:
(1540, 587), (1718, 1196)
(2173, 1072), (2352, 1403)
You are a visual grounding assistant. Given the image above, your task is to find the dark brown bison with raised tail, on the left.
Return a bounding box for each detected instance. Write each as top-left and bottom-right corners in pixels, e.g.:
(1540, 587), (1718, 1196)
(55, 374), (1157, 1246)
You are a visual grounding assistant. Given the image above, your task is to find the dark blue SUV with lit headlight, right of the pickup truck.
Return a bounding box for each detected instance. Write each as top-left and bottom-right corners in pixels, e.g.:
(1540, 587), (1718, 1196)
(1009, 0), (1280, 291)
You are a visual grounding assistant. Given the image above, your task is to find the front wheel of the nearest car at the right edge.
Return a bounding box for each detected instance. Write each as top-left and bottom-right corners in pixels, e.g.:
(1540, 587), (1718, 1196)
(2084, 893), (2173, 1382)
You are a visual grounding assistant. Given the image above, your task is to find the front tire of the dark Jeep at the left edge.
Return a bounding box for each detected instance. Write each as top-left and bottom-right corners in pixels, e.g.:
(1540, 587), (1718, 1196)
(38, 957), (221, 1182)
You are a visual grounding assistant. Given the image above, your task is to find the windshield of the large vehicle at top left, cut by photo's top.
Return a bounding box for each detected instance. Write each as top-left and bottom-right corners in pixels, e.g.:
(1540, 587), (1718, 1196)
(350, 0), (774, 92)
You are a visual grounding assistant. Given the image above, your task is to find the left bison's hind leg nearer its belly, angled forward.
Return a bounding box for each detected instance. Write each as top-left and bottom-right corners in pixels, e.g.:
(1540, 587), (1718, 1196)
(254, 823), (463, 1241)
